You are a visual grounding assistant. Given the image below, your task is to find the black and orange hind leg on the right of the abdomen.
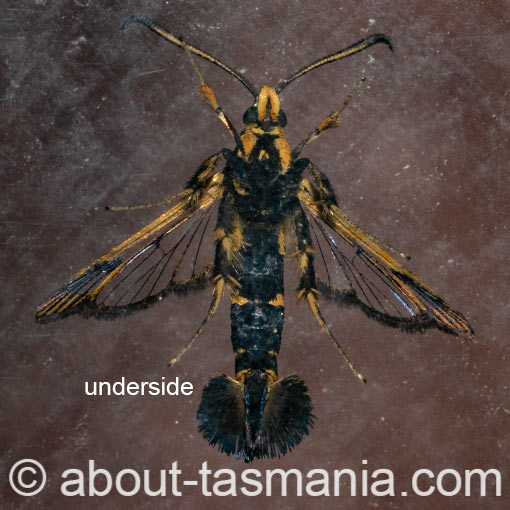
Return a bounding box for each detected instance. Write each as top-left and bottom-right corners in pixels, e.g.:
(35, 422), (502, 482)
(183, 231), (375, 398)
(294, 207), (366, 382)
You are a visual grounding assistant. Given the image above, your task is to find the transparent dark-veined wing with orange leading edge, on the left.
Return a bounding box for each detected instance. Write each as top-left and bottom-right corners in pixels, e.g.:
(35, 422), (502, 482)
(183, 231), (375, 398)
(36, 163), (223, 322)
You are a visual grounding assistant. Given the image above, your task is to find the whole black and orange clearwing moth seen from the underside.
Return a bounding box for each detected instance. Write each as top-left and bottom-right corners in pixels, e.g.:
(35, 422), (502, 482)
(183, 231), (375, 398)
(36, 16), (473, 462)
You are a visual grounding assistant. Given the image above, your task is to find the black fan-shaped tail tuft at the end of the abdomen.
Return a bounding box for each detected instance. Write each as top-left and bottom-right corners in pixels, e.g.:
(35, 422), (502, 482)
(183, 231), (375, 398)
(197, 369), (314, 462)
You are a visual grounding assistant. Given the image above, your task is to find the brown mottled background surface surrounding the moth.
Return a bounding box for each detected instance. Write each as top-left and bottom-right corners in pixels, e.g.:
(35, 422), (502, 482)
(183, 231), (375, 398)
(0, 0), (510, 510)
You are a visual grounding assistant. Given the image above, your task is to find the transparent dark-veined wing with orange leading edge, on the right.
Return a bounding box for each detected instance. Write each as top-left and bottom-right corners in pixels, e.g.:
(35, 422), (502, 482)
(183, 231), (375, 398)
(299, 179), (473, 338)
